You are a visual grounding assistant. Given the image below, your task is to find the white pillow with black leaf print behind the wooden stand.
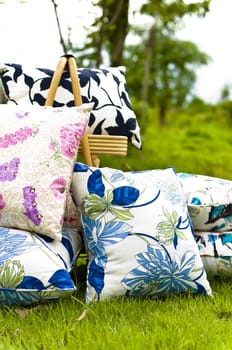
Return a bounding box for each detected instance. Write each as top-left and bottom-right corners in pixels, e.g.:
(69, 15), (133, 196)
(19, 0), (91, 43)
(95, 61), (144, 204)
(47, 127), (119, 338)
(0, 64), (141, 149)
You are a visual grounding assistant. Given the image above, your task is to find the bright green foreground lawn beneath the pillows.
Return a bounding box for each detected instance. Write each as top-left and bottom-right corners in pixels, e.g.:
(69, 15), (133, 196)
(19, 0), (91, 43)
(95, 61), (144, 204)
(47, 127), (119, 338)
(0, 280), (232, 350)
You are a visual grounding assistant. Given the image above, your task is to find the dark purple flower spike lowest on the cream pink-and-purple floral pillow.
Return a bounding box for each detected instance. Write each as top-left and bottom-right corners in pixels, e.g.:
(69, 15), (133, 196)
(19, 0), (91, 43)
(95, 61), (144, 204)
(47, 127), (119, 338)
(23, 186), (43, 226)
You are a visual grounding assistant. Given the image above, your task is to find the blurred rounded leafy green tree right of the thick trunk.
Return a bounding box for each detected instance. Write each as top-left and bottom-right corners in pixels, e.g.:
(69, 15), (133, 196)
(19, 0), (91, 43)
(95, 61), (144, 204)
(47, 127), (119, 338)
(125, 33), (209, 125)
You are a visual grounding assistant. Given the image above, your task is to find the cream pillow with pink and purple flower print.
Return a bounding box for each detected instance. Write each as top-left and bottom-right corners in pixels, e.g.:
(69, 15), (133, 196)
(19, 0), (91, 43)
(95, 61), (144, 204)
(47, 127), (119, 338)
(0, 105), (91, 240)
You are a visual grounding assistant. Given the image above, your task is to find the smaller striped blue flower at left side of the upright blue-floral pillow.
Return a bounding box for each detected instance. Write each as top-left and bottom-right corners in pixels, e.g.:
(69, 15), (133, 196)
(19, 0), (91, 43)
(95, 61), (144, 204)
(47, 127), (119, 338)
(82, 217), (131, 267)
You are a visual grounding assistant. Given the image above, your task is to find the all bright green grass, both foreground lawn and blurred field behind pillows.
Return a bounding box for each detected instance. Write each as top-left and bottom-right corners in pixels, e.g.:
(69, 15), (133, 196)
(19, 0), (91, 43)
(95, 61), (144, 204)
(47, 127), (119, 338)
(0, 108), (232, 350)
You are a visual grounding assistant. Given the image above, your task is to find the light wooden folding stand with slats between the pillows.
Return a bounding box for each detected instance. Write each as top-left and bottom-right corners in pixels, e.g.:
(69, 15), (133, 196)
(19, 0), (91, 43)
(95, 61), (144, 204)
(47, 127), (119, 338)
(45, 55), (128, 167)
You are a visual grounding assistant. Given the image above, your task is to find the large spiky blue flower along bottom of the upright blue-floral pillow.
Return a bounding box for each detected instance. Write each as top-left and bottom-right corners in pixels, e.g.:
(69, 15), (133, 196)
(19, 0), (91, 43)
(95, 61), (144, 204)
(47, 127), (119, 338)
(121, 245), (205, 297)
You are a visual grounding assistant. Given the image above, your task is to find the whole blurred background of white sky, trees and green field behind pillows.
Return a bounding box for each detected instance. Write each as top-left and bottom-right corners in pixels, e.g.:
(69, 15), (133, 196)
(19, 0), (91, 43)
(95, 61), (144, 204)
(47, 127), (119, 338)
(0, 0), (232, 178)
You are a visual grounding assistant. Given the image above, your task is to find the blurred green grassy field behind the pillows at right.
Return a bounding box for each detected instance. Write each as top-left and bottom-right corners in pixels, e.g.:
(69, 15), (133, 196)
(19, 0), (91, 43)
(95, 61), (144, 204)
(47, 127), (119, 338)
(101, 105), (232, 180)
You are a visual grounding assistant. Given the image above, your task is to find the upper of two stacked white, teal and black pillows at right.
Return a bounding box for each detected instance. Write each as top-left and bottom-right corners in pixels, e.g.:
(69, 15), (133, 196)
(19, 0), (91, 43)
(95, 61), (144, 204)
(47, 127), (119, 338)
(178, 173), (232, 232)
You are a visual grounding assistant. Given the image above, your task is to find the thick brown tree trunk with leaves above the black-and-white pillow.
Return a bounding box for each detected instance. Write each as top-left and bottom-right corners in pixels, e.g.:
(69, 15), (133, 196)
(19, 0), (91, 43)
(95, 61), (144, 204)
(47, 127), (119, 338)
(64, 0), (129, 67)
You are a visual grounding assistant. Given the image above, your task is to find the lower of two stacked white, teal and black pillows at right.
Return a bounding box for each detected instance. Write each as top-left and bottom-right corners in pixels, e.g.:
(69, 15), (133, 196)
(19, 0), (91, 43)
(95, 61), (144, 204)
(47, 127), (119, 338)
(196, 231), (232, 278)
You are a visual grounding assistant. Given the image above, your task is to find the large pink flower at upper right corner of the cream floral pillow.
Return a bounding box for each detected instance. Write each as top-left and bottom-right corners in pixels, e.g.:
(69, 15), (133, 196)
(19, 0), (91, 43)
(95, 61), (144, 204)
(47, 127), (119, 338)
(60, 123), (83, 159)
